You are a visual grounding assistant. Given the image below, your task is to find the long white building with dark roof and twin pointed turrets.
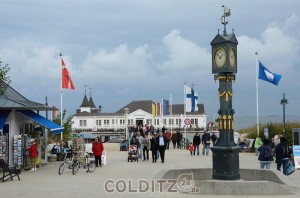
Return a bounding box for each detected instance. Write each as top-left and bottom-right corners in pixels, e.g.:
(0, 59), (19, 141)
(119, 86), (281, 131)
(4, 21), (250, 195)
(72, 95), (206, 132)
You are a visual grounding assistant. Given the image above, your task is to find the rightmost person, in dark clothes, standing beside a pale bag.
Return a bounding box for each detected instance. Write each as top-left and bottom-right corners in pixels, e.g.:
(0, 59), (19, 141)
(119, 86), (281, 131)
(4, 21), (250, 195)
(275, 137), (291, 175)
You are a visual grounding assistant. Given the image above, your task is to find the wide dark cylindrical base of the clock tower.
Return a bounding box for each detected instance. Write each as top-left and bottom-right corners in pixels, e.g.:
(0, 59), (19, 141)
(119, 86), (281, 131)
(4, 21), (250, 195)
(211, 145), (240, 180)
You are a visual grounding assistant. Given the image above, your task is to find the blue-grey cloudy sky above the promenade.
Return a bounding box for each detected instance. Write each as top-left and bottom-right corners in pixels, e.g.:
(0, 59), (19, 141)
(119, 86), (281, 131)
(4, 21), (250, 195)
(0, 0), (300, 120)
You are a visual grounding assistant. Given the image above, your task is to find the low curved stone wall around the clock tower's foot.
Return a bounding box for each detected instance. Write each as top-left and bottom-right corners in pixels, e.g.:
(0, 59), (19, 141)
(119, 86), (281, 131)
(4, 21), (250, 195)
(162, 168), (293, 195)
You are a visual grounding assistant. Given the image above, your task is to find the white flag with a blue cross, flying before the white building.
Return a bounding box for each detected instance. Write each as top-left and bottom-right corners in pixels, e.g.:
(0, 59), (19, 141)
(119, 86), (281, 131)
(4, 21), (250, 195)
(184, 85), (198, 112)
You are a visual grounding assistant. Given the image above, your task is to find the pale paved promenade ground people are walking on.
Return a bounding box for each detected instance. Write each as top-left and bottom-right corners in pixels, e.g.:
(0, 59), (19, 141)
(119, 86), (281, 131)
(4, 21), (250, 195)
(0, 145), (300, 198)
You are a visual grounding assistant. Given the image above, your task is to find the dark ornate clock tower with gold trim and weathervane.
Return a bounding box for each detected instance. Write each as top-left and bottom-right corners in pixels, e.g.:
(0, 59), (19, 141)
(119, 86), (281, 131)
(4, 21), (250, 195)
(210, 6), (240, 180)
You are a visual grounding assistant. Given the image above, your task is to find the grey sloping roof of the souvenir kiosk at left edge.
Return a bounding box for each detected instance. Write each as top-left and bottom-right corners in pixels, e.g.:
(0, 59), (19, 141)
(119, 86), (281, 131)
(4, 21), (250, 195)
(0, 80), (52, 110)
